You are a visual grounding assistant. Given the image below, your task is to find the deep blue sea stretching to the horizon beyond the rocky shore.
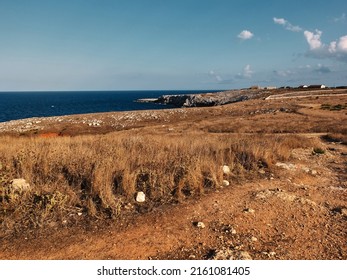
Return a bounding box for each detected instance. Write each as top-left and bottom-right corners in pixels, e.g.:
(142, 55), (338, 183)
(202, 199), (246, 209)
(0, 90), (219, 122)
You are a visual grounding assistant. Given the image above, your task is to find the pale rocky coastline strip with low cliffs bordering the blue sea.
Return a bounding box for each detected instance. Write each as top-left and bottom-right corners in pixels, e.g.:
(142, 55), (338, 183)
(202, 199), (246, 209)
(0, 89), (347, 136)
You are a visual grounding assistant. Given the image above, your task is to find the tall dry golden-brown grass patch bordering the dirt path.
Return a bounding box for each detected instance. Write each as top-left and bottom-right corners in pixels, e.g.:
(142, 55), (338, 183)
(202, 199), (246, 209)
(0, 131), (313, 236)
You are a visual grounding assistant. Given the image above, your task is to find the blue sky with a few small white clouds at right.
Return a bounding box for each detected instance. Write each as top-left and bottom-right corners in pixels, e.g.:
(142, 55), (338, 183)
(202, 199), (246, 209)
(0, 0), (347, 91)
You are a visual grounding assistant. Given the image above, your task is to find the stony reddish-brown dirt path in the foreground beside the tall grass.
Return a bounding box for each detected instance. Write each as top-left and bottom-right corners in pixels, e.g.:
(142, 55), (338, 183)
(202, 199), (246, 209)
(0, 135), (347, 259)
